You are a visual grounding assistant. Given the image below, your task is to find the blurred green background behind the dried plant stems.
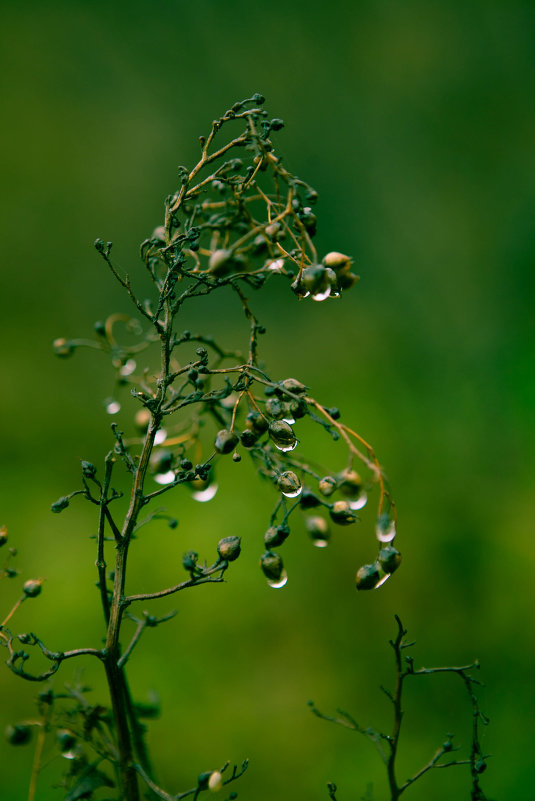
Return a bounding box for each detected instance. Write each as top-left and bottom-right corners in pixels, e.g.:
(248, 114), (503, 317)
(0, 0), (535, 801)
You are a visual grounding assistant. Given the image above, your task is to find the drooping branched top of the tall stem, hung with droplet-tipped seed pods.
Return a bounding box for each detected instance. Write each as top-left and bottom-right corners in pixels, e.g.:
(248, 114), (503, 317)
(53, 94), (401, 589)
